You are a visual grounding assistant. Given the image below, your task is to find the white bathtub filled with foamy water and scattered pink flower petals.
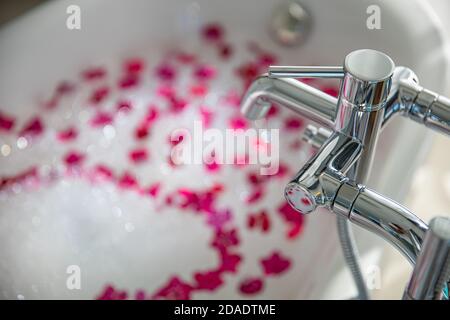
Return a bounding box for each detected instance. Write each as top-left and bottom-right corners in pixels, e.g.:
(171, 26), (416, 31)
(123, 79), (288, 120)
(0, 0), (449, 299)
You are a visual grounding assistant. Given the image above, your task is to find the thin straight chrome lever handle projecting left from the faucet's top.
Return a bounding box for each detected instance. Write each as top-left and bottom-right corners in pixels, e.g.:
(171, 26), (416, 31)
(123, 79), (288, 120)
(269, 66), (344, 79)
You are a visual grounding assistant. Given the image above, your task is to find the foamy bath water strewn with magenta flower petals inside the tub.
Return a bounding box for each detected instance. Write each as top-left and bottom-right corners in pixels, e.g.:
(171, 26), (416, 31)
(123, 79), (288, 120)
(0, 23), (336, 299)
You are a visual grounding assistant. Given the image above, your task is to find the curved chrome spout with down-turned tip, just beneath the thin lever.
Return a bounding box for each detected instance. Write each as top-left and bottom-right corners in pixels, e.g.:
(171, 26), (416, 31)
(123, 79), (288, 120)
(241, 74), (337, 128)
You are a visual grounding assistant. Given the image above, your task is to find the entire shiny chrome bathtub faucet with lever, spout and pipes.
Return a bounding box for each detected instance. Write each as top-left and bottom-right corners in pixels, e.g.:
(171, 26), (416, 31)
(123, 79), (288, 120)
(241, 49), (450, 299)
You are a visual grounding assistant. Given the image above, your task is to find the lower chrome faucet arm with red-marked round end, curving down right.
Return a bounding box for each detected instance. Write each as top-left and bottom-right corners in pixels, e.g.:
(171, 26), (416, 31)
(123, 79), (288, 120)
(285, 133), (428, 265)
